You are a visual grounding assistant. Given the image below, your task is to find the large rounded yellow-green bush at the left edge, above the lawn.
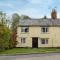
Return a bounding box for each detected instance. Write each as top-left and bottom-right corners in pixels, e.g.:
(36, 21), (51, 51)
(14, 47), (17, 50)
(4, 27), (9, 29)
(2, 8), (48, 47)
(0, 23), (10, 51)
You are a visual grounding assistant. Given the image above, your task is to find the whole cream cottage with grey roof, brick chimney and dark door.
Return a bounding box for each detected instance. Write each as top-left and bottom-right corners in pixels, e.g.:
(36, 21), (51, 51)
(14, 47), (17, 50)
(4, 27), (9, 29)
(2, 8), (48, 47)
(16, 9), (60, 48)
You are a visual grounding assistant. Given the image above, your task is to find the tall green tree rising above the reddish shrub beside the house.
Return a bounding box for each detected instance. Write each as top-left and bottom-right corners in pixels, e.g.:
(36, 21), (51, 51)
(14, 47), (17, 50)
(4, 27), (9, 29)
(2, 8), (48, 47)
(11, 13), (20, 31)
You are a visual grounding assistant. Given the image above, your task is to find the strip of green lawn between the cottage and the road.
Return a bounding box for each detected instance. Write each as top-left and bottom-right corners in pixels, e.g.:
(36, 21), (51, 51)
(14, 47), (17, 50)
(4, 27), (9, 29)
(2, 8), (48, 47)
(0, 48), (60, 54)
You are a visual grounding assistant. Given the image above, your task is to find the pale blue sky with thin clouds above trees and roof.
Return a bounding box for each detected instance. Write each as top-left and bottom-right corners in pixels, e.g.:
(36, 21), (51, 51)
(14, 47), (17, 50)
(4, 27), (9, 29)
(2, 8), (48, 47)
(0, 0), (60, 18)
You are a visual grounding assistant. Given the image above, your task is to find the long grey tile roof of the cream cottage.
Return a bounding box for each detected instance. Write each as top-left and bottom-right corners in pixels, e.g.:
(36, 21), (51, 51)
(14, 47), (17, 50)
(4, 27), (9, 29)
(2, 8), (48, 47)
(19, 19), (60, 26)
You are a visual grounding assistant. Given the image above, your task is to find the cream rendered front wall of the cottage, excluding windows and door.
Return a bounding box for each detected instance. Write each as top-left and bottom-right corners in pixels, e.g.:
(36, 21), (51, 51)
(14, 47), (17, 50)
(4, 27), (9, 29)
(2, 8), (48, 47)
(17, 26), (60, 47)
